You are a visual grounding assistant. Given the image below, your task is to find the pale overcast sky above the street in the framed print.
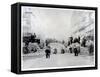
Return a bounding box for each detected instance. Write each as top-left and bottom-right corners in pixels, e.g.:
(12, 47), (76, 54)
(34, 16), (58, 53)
(22, 6), (95, 40)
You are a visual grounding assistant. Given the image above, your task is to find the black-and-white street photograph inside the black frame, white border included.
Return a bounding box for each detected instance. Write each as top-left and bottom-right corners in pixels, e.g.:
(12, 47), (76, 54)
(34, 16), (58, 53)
(21, 6), (95, 71)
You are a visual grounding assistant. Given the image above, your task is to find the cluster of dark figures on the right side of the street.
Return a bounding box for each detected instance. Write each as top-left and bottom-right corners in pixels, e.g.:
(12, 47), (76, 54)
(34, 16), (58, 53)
(68, 36), (94, 56)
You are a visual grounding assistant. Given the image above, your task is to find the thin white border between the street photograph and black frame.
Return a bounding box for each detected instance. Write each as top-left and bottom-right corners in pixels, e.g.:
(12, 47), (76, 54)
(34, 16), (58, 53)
(21, 6), (95, 71)
